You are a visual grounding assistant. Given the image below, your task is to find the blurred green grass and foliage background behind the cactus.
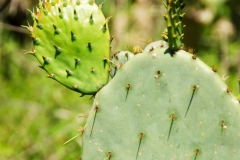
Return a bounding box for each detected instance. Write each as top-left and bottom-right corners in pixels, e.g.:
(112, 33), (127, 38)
(0, 0), (240, 160)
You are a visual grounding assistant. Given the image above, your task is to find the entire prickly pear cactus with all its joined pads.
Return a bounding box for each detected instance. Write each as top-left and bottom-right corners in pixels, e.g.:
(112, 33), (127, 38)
(23, 0), (240, 160)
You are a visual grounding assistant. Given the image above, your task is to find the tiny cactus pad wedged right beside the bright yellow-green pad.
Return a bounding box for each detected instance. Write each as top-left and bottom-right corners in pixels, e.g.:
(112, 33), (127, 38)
(109, 51), (134, 78)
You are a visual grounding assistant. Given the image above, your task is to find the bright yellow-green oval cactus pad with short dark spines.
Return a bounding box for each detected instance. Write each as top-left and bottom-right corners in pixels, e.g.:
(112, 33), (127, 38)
(25, 0), (110, 94)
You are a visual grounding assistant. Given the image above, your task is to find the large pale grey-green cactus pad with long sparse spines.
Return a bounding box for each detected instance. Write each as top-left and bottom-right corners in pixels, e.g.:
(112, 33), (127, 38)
(82, 43), (240, 160)
